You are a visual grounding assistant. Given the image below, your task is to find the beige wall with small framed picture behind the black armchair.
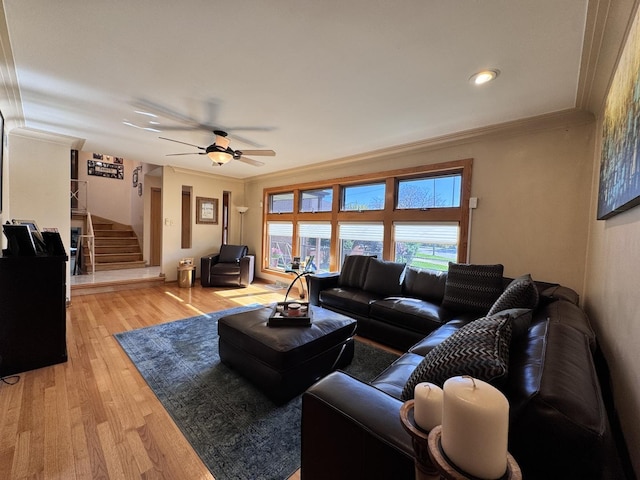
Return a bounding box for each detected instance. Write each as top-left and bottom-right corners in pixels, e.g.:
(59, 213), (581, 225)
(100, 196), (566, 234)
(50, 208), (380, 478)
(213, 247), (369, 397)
(162, 167), (244, 281)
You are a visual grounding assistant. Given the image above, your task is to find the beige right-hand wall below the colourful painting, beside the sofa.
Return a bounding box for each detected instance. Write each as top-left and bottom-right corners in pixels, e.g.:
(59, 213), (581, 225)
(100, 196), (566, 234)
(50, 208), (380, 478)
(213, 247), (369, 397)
(584, 118), (640, 473)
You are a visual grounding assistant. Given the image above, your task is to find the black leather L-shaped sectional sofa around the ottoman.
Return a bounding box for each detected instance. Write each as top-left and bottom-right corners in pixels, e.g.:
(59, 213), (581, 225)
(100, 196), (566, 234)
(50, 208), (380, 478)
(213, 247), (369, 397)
(301, 257), (626, 480)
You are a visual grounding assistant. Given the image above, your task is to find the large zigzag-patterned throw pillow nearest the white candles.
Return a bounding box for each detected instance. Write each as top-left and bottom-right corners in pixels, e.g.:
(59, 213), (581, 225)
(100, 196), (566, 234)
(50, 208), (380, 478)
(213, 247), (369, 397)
(402, 313), (512, 400)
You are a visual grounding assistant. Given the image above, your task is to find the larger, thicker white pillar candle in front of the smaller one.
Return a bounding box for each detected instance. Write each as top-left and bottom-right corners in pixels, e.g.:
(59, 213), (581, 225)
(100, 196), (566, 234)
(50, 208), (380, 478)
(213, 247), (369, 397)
(442, 376), (509, 479)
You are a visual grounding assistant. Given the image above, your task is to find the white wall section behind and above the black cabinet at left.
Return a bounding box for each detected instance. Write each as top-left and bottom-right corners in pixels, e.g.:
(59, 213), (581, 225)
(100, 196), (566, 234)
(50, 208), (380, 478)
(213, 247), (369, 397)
(7, 129), (74, 298)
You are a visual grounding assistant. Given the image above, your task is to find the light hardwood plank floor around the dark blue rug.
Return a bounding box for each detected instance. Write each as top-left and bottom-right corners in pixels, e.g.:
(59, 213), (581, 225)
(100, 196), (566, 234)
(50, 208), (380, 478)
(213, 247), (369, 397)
(0, 283), (310, 480)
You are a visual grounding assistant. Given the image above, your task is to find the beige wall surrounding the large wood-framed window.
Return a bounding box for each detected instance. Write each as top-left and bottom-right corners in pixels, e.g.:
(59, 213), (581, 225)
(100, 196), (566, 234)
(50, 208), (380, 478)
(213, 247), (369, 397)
(245, 112), (594, 293)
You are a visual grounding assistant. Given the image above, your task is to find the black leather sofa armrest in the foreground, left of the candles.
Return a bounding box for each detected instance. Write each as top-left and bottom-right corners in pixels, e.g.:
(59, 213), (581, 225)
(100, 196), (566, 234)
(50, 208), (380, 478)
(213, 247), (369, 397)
(301, 371), (415, 480)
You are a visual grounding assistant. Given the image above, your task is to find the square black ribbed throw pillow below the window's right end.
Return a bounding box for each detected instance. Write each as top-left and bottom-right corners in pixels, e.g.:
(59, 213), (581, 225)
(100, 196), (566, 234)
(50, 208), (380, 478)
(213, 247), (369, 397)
(442, 262), (504, 315)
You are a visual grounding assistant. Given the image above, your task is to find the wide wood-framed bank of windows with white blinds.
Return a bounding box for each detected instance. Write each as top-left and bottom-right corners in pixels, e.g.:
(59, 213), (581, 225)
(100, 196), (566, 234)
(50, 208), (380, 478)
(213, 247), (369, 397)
(261, 158), (473, 281)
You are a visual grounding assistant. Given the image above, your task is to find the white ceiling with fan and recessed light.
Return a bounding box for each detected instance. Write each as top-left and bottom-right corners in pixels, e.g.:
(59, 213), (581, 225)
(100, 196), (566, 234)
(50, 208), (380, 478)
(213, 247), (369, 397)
(4, 0), (588, 178)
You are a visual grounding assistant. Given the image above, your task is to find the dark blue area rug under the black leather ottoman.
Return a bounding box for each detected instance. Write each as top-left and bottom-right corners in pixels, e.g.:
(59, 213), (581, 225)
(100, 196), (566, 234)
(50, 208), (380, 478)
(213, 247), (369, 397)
(115, 305), (397, 480)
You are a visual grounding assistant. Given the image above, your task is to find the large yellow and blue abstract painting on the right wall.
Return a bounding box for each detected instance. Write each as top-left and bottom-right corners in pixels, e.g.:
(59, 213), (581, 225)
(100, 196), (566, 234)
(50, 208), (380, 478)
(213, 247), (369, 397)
(598, 9), (640, 220)
